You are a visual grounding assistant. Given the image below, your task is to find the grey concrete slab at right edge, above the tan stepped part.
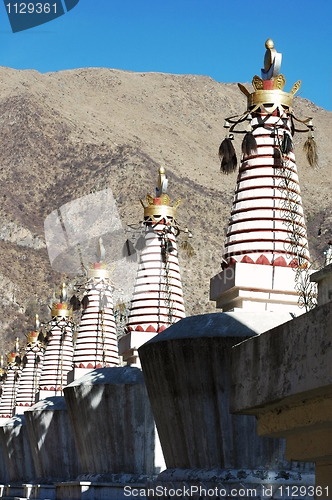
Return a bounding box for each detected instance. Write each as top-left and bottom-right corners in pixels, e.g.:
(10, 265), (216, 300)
(230, 302), (332, 415)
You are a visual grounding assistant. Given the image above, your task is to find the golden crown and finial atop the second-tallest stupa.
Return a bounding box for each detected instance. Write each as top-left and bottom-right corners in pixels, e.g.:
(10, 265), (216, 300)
(140, 167), (181, 222)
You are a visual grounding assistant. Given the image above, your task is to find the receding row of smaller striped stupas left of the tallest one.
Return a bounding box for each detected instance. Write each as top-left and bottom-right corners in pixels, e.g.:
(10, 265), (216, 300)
(0, 167), (185, 418)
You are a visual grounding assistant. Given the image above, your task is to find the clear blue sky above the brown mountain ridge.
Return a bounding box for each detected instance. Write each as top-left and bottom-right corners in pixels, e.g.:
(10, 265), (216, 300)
(0, 0), (332, 110)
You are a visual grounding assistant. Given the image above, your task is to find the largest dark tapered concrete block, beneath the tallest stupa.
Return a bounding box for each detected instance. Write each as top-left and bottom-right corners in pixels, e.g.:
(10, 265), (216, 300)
(139, 312), (313, 498)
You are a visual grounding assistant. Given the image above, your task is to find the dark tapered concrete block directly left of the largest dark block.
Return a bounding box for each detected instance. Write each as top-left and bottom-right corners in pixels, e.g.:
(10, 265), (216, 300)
(64, 367), (155, 480)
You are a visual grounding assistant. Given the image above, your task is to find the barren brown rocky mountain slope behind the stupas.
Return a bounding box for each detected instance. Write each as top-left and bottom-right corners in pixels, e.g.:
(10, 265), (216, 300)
(0, 67), (332, 352)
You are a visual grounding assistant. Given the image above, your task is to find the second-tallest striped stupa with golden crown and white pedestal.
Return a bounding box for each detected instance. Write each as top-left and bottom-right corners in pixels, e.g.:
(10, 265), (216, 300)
(119, 167), (185, 364)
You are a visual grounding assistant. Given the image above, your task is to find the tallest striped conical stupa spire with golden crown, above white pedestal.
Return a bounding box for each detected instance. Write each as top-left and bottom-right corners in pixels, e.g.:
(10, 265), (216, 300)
(223, 39), (309, 266)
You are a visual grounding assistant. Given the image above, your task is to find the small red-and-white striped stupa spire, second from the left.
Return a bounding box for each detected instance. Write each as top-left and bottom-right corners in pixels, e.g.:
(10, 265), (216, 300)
(15, 331), (45, 415)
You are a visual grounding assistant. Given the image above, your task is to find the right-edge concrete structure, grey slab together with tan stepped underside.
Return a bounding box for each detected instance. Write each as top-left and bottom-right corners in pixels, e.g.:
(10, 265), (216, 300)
(230, 302), (332, 498)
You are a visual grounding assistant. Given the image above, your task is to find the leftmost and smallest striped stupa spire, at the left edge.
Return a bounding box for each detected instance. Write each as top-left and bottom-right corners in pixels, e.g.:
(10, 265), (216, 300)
(0, 352), (22, 419)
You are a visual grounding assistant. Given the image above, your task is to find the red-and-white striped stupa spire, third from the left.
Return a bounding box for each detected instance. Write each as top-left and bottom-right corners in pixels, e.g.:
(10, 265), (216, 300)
(36, 302), (74, 401)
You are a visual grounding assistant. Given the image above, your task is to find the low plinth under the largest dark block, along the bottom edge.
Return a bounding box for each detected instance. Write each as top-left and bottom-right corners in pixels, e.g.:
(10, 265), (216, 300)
(146, 469), (315, 500)
